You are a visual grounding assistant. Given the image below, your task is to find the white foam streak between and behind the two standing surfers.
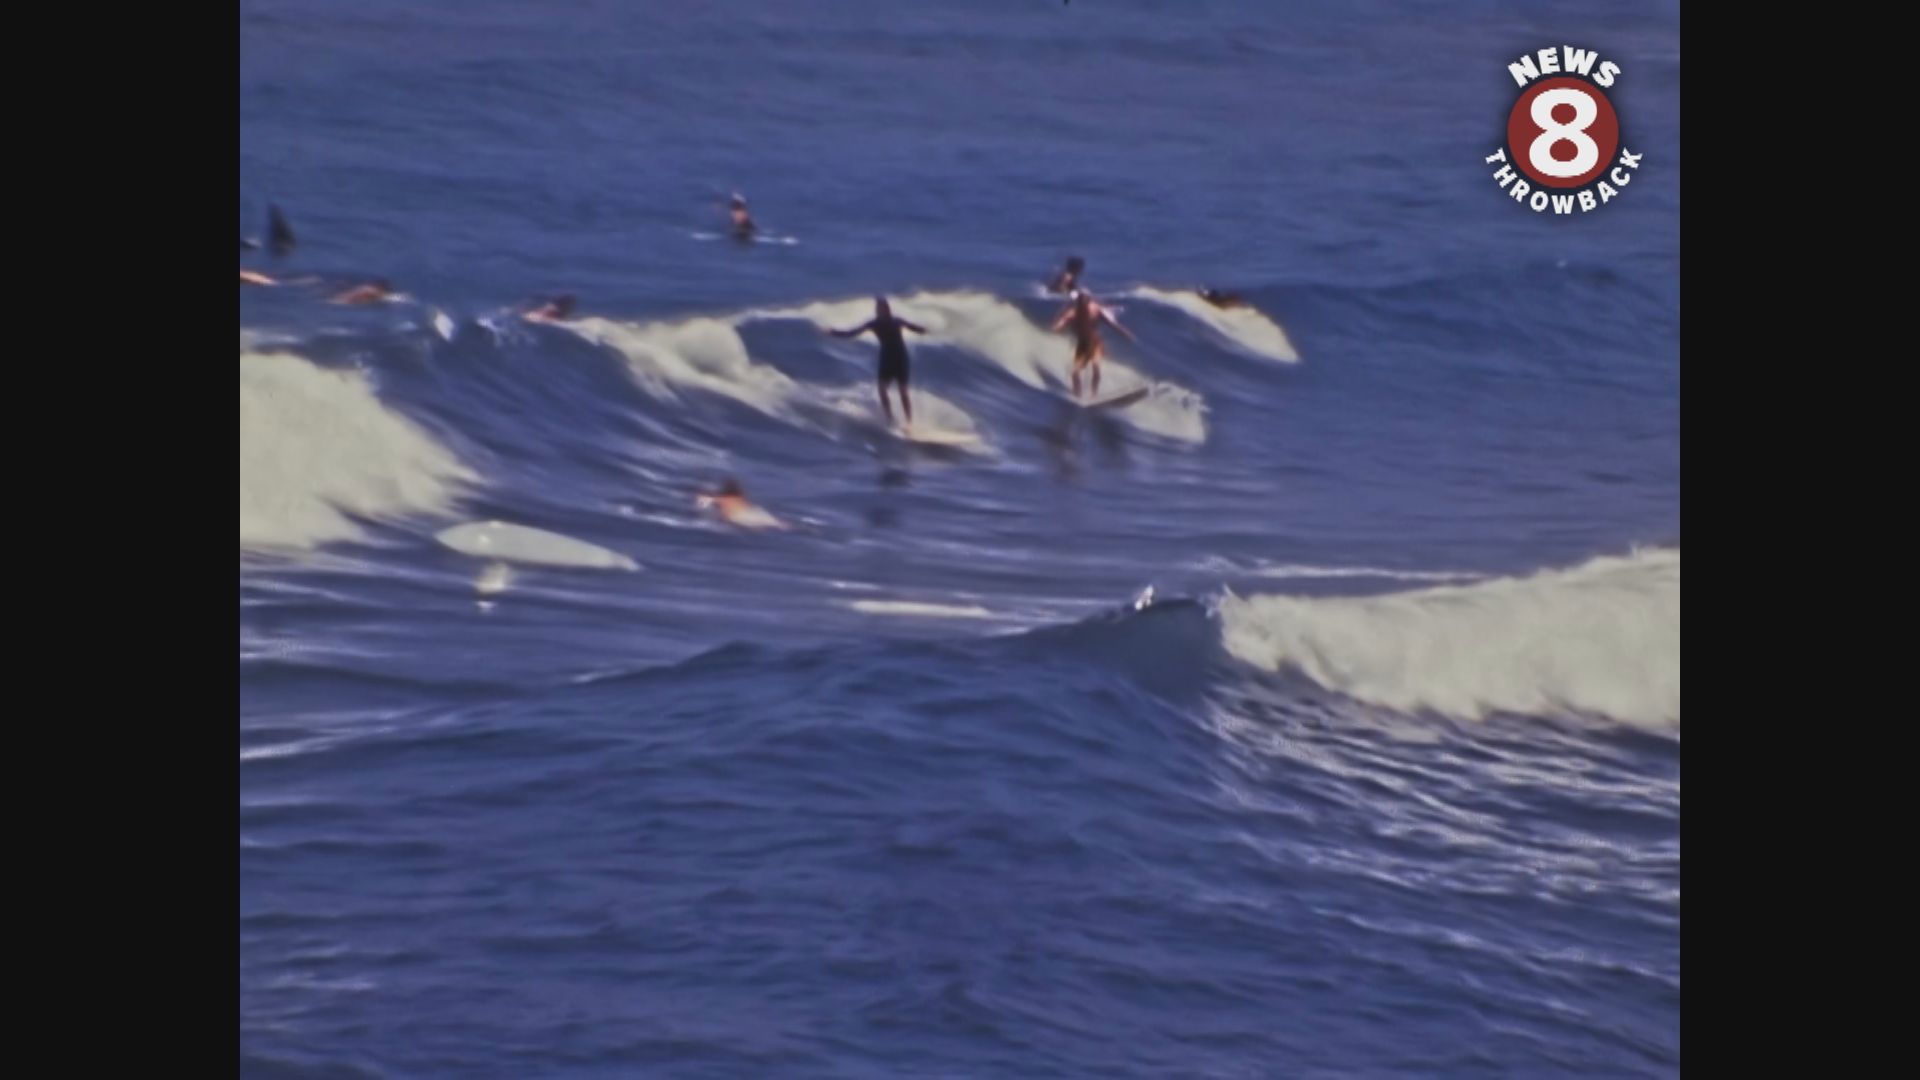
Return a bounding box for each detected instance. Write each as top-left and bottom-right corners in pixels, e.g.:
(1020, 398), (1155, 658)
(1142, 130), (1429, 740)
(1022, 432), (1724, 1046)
(735, 292), (1206, 442)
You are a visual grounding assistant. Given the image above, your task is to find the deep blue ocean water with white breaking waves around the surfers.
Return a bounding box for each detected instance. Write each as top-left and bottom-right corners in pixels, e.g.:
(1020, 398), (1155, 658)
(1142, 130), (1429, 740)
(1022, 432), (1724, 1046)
(238, 0), (1680, 1078)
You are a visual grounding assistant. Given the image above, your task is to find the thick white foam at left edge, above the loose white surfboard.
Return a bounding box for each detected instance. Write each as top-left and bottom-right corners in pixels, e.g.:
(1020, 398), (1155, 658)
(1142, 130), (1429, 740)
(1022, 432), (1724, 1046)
(240, 338), (476, 550)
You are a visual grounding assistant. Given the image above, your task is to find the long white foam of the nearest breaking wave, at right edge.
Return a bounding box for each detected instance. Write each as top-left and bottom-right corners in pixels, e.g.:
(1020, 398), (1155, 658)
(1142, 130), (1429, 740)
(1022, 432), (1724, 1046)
(1219, 550), (1680, 728)
